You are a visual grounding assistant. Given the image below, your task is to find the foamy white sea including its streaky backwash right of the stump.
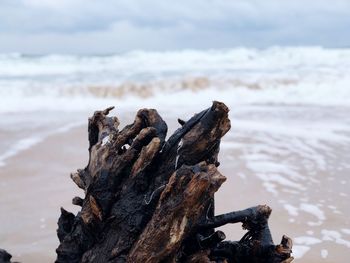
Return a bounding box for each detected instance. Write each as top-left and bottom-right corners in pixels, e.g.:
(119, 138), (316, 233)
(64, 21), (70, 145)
(0, 46), (350, 262)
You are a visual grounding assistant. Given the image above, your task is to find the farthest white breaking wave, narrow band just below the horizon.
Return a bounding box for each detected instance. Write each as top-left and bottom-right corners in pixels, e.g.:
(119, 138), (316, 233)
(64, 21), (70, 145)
(0, 47), (350, 77)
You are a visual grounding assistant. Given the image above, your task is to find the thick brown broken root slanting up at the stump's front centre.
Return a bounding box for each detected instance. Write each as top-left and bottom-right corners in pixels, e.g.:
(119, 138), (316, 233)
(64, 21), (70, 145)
(128, 162), (226, 263)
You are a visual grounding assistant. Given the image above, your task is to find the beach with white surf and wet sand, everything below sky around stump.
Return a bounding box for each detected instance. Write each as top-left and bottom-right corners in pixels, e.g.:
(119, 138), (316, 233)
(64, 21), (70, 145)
(0, 48), (350, 263)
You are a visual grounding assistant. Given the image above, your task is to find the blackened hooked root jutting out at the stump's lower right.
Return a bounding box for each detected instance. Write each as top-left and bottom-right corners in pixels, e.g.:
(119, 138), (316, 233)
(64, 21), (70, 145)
(206, 205), (293, 263)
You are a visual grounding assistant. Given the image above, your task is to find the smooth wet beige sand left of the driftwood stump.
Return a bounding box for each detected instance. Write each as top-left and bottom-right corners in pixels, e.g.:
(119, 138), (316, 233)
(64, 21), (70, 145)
(0, 127), (88, 262)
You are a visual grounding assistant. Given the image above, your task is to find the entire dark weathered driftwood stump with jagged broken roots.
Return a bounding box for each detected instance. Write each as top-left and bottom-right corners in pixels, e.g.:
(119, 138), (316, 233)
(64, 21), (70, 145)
(56, 102), (292, 263)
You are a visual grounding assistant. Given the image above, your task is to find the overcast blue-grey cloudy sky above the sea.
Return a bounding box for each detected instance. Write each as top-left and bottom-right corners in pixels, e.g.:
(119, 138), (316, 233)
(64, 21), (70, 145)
(0, 0), (350, 54)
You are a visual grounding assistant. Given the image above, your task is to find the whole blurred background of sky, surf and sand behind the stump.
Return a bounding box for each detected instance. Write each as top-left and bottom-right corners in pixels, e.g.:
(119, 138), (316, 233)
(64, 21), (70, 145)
(0, 0), (350, 263)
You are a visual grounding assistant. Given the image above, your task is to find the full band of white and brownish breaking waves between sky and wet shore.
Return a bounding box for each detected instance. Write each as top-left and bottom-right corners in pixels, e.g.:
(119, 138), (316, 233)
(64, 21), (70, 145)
(0, 47), (350, 112)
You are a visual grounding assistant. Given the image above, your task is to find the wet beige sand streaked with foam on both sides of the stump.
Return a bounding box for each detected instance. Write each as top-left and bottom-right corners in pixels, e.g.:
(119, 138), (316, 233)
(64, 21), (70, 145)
(0, 106), (350, 263)
